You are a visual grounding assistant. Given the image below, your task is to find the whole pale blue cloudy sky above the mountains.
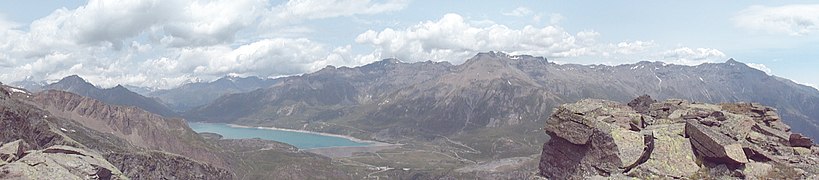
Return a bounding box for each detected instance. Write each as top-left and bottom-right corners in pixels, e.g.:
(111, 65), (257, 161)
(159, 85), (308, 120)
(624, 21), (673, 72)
(0, 0), (819, 89)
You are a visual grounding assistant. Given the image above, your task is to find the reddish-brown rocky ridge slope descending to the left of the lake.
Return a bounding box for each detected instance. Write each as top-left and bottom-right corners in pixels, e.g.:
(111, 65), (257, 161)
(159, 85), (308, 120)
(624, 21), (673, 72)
(32, 90), (226, 167)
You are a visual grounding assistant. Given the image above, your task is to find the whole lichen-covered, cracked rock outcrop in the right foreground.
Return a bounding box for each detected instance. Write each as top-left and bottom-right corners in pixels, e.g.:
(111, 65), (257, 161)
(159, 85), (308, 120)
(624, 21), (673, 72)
(540, 96), (819, 179)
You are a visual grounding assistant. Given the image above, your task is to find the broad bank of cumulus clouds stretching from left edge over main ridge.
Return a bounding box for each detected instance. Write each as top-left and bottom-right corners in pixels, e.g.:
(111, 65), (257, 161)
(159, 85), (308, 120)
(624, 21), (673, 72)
(0, 0), (748, 88)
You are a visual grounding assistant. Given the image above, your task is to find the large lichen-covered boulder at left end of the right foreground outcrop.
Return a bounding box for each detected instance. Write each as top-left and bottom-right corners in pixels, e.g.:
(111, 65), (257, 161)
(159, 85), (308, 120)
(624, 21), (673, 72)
(540, 100), (647, 179)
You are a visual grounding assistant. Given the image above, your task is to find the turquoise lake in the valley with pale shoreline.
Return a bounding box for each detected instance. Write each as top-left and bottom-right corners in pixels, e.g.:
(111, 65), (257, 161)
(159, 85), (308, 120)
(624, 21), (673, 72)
(188, 122), (371, 149)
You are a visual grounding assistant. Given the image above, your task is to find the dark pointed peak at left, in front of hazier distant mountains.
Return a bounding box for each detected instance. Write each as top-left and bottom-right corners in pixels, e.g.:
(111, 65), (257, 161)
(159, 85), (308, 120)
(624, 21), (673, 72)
(43, 75), (177, 117)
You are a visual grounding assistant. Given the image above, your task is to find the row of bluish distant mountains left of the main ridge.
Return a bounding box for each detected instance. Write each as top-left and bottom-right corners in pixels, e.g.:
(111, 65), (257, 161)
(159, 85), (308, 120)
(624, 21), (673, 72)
(12, 75), (275, 117)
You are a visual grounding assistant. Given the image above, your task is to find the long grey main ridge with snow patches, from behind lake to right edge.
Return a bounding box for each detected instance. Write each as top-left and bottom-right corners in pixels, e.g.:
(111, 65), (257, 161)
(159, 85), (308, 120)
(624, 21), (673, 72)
(186, 52), (819, 141)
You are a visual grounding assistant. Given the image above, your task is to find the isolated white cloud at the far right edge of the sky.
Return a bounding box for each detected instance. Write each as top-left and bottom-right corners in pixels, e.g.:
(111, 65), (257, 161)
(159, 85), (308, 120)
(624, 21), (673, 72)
(732, 4), (819, 36)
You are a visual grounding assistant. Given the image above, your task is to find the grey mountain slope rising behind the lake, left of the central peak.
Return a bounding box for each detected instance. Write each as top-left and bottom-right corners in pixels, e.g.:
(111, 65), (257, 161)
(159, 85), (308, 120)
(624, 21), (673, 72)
(186, 59), (451, 125)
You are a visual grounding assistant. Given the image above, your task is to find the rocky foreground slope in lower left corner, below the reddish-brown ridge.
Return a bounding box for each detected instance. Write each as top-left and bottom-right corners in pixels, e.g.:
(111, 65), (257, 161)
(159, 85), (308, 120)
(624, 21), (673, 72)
(0, 86), (232, 179)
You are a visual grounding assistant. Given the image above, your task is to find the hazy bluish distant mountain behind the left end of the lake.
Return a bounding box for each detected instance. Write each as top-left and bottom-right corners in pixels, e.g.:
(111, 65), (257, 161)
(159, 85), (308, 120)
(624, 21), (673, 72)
(152, 76), (276, 112)
